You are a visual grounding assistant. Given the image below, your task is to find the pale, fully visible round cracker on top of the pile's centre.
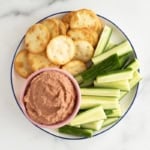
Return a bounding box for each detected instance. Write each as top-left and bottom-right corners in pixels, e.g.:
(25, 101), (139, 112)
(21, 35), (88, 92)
(47, 35), (75, 65)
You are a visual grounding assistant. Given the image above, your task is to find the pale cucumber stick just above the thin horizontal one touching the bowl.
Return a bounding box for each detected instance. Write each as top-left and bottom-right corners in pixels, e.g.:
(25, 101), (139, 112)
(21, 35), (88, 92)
(94, 80), (130, 91)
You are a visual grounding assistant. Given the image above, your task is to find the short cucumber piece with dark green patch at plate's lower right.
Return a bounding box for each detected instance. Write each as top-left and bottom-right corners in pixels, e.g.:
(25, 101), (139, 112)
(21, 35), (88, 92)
(105, 107), (122, 118)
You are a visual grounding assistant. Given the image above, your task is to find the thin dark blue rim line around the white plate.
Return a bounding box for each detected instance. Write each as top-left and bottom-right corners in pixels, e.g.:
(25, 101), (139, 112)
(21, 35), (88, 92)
(10, 11), (139, 140)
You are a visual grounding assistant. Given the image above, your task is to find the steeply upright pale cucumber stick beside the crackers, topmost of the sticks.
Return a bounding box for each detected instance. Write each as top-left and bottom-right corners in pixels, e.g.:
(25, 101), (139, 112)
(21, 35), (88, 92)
(94, 25), (112, 56)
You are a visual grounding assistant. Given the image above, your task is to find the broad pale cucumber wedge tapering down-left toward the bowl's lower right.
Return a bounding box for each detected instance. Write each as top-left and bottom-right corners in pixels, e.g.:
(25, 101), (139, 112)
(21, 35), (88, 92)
(70, 106), (106, 126)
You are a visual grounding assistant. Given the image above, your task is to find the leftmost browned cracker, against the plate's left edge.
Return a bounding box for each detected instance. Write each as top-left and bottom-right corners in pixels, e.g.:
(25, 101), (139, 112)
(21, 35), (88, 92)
(14, 50), (32, 78)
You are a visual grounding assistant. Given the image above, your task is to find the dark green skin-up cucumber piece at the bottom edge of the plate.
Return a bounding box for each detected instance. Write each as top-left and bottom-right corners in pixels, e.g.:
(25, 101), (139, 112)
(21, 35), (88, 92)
(58, 125), (93, 137)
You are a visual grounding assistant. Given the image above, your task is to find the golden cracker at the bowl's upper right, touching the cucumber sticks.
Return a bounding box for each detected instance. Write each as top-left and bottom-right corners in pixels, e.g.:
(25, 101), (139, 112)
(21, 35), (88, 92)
(62, 60), (86, 76)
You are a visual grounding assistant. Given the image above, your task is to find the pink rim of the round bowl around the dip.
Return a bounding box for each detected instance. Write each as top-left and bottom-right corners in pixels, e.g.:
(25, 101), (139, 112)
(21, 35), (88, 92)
(18, 67), (81, 129)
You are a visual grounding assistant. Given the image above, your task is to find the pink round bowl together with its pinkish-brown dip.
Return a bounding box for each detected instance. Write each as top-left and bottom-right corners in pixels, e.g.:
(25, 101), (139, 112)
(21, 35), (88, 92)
(20, 68), (81, 128)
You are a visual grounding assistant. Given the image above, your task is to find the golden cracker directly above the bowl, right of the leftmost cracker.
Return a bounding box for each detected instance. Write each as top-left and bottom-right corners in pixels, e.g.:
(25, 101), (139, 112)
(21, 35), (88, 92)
(28, 52), (59, 71)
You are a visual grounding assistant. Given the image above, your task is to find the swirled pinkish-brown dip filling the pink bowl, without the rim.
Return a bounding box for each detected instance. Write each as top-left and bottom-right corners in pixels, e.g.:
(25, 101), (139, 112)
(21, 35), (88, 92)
(23, 71), (76, 125)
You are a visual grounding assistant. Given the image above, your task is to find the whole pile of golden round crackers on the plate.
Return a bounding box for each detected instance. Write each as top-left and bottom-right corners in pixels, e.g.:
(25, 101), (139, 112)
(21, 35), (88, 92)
(14, 9), (104, 78)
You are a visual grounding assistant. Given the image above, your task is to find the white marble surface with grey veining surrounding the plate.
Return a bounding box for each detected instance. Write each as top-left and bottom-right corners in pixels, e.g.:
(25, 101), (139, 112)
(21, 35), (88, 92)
(0, 0), (150, 150)
